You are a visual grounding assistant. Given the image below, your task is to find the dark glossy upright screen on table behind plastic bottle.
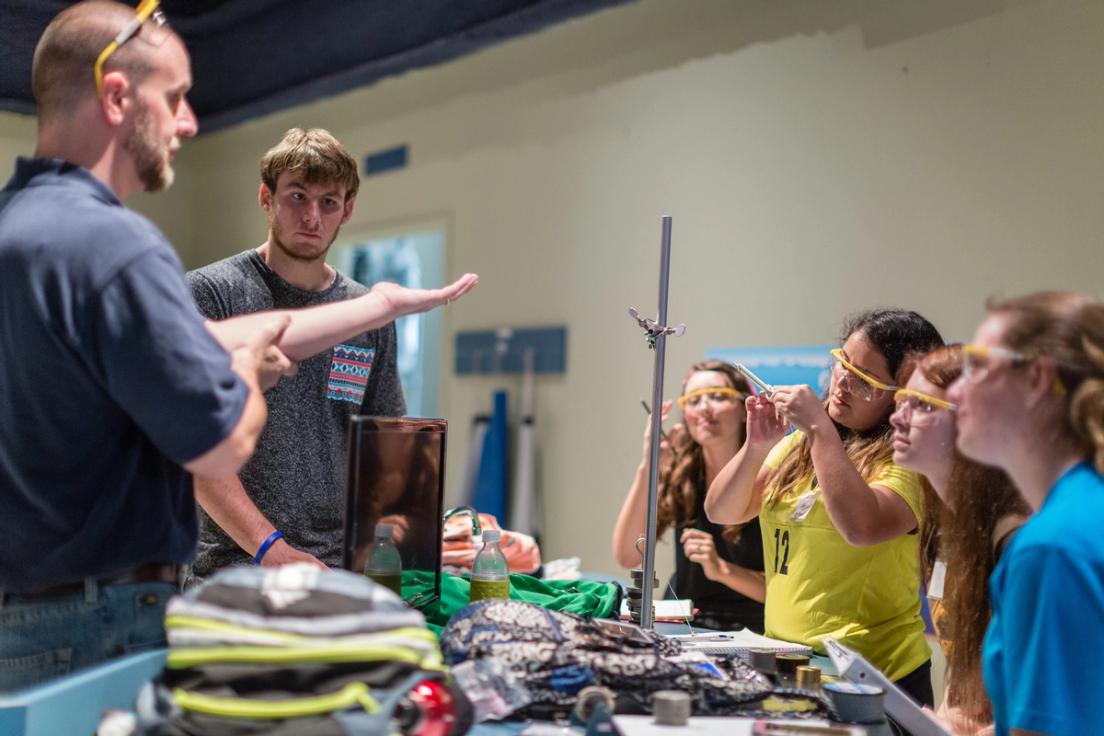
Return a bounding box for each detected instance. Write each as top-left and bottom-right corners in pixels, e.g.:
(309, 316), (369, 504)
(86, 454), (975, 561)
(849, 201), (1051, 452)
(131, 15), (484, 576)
(342, 415), (448, 606)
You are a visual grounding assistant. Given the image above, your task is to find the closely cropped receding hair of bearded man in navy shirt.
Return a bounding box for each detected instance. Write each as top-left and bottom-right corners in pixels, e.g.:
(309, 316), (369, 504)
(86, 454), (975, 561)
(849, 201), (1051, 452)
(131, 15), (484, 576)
(31, 0), (172, 118)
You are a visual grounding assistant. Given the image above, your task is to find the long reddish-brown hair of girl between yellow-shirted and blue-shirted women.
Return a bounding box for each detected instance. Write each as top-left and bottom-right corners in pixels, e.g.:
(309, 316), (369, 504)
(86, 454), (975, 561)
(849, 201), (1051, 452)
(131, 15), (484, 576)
(917, 344), (1030, 723)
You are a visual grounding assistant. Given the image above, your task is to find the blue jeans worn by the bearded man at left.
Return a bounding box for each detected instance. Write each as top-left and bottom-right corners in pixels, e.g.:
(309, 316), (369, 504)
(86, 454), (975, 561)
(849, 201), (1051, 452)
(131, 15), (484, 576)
(0, 580), (177, 692)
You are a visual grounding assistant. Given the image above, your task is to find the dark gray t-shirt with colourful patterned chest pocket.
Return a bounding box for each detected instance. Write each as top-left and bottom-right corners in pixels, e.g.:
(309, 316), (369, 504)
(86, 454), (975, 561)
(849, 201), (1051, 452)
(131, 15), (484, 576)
(188, 250), (406, 577)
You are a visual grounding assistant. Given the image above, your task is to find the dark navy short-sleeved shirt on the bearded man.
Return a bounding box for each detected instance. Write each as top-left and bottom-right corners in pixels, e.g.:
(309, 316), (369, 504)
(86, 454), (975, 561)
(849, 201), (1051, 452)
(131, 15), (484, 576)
(0, 159), (248, 591)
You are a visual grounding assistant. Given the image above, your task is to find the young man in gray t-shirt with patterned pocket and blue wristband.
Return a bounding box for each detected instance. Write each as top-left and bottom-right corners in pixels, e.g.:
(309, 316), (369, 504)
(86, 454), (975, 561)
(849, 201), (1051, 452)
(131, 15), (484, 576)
(188, 128), (474, 577)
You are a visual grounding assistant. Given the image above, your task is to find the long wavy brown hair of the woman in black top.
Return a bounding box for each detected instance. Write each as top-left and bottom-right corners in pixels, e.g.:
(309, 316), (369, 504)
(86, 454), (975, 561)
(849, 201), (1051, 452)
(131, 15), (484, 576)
(656, 359), (751, 543)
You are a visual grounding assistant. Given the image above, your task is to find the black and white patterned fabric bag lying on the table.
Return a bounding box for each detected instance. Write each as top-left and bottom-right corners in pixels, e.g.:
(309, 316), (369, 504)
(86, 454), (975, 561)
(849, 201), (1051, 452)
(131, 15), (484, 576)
(440, 600), (772, 717)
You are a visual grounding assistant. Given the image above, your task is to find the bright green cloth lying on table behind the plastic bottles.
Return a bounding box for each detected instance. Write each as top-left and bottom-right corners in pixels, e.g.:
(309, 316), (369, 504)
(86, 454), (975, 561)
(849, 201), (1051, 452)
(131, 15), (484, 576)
(403, 570), (622, 637)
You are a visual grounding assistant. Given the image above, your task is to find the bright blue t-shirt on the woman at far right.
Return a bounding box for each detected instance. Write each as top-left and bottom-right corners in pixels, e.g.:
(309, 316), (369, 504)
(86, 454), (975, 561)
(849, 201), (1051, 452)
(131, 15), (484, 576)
(983, 462), (1104, 736)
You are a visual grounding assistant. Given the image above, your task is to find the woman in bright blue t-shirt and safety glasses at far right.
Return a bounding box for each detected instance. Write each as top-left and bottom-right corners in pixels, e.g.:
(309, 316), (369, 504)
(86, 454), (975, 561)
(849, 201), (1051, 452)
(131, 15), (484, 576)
(949, 292), (1104, 736)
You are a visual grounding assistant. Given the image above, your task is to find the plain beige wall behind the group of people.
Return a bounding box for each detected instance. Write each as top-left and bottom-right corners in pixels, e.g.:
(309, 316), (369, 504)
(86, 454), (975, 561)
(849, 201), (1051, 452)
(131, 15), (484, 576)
(0, 0), (1104, 587)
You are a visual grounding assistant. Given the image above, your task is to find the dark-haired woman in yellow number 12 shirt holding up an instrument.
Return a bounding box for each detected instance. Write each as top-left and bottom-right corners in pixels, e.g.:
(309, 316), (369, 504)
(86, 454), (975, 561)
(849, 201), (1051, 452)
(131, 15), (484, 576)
(705, 309), (943, 706)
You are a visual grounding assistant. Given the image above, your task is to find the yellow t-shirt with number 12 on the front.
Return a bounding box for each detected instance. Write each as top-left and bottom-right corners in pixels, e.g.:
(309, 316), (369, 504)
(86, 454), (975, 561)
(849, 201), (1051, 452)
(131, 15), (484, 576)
(760, 431), (932, 680)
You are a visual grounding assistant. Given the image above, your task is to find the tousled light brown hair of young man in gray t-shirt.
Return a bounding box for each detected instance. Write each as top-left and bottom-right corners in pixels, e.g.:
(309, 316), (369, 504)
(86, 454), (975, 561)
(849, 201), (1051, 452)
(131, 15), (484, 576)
(261, 128), (360, 202)
